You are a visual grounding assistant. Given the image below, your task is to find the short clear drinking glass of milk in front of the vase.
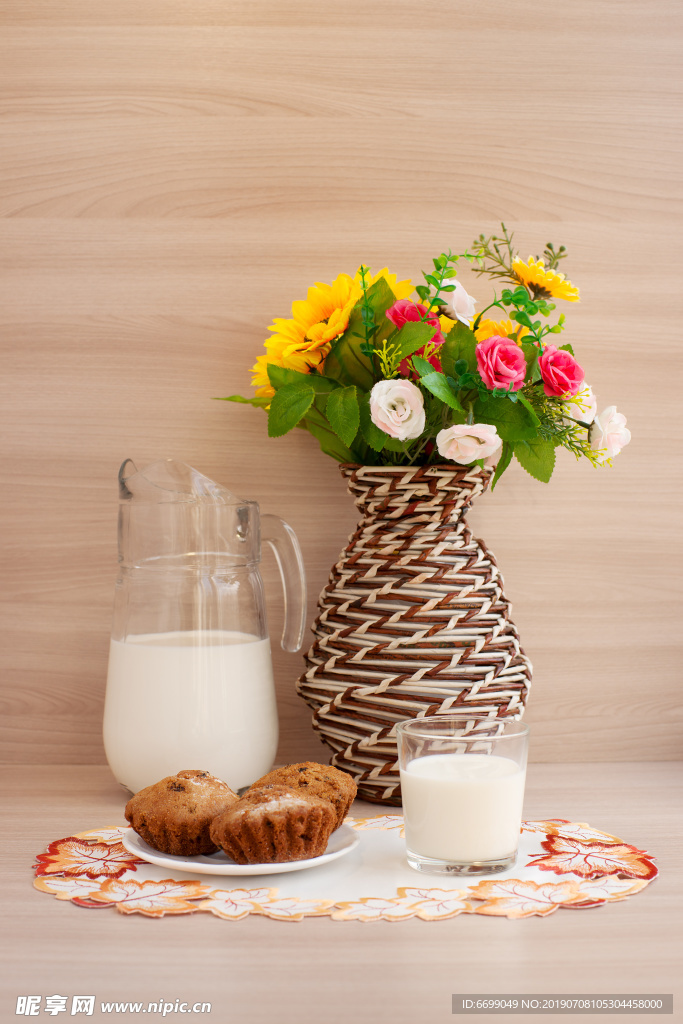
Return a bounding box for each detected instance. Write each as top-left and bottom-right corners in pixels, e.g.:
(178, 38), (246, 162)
(396, 713), (528, 874)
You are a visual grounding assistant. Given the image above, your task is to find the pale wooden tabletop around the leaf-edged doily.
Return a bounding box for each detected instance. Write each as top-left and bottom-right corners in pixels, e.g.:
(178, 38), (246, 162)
(0, 762), (683, 1024)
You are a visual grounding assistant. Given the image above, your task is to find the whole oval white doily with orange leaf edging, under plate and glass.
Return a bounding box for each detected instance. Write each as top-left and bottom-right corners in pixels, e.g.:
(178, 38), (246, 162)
(34, 814), (657, 922)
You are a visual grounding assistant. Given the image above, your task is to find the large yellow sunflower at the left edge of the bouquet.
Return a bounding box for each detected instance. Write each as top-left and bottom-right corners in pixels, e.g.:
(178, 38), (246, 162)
(252, 267), (413, 397)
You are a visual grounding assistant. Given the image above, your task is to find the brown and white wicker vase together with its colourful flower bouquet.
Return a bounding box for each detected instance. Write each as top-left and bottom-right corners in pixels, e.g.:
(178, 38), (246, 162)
(223, 225), (630, 804)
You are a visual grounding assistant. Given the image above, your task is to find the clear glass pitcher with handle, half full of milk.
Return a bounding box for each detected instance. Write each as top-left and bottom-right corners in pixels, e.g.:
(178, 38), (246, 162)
(103, 459), (306, 793)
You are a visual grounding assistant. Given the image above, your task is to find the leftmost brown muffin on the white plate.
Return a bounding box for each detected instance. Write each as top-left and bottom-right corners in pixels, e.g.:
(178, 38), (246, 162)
(126, 771), (240, 857)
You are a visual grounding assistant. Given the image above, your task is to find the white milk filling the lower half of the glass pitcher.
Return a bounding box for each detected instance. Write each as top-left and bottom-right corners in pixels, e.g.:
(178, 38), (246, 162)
(104, 630), (278, 793)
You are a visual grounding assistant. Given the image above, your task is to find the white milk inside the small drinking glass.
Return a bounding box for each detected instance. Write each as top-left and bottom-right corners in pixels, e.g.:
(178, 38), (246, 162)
(400, 754), (525, 863)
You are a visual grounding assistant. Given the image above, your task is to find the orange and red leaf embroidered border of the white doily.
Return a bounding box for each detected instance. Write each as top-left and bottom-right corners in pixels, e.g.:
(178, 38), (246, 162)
(34, 814), (657, 922)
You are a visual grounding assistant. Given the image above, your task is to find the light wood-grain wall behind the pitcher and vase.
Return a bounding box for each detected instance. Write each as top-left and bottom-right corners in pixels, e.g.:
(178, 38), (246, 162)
(0, 0), (683, 764)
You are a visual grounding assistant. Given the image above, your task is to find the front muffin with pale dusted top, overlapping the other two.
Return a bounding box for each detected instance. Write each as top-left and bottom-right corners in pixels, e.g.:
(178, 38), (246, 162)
(211, 785), (336, 864)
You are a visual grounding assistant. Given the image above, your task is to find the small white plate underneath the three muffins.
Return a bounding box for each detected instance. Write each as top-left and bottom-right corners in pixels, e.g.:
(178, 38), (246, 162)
(121, 825), (358, 874)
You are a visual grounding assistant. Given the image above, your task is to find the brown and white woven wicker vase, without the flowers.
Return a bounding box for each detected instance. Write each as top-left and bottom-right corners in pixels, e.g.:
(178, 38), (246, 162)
(297, 465), (531, 804)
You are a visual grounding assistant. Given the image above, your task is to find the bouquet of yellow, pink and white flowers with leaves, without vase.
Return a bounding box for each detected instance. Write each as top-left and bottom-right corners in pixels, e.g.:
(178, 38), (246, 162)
(224, 224), (631, 486)
